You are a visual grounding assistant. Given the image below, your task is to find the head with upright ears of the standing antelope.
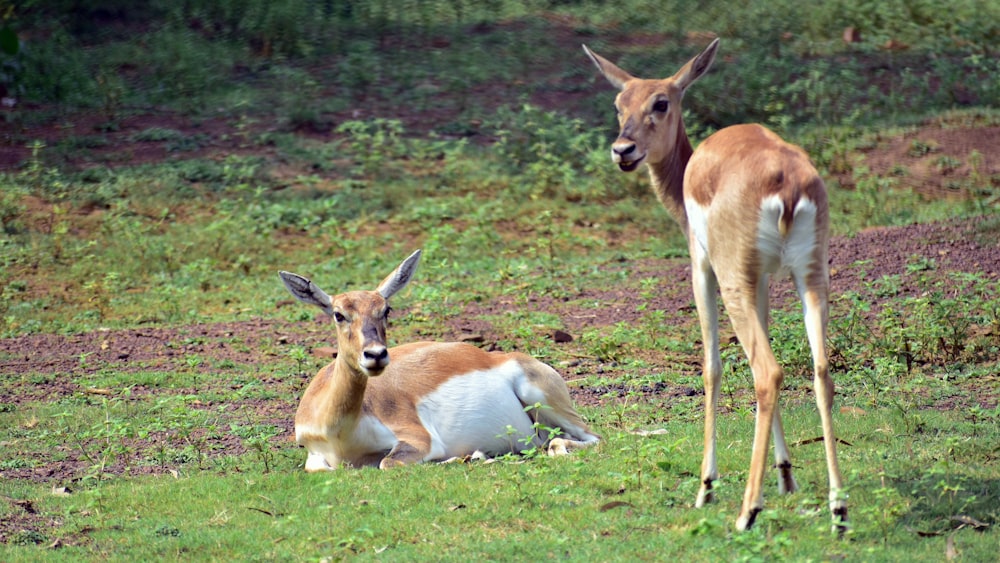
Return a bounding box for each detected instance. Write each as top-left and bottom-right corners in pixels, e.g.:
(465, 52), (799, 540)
(583, 39), (719, 172)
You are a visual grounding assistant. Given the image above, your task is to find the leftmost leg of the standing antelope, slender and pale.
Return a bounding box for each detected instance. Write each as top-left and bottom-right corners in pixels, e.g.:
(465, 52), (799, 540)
(691, 258), (722, 508)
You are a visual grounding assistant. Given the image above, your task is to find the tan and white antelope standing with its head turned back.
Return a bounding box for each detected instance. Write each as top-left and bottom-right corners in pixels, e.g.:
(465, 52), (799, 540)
(583, 39), (847, 530)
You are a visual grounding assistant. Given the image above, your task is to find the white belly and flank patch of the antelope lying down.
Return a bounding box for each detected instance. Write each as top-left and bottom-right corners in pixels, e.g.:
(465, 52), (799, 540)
(417, 360), (541, 461)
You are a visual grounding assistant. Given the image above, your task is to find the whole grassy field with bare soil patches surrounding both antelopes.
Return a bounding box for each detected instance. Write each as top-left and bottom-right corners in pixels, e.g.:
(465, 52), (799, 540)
(0, 0), (1000, 561)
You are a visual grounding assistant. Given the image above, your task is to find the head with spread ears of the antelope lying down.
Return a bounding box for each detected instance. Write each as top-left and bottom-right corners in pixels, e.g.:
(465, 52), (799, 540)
(279, 250), (420, 377)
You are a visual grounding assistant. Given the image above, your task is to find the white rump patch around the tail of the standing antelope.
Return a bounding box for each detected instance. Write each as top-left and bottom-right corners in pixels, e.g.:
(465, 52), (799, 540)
(757, 195), (816, 276)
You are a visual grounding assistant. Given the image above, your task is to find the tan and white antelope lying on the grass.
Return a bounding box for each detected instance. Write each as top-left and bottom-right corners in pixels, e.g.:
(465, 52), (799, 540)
(280, 250), (599, 472)
